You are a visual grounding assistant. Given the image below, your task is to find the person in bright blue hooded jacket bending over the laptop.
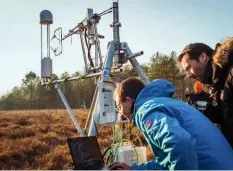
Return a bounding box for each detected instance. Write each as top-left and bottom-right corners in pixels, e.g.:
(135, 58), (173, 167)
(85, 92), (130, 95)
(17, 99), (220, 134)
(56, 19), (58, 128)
(109, 78), (233, 170)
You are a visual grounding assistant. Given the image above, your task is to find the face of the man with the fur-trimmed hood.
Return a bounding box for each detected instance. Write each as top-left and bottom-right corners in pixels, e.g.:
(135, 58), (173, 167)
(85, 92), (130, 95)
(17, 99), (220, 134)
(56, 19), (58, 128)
(181, 53), (209, 82)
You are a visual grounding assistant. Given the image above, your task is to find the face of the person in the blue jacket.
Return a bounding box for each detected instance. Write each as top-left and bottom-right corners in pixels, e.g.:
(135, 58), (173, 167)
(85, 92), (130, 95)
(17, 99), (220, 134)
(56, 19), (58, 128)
(115, 95), (132, 120)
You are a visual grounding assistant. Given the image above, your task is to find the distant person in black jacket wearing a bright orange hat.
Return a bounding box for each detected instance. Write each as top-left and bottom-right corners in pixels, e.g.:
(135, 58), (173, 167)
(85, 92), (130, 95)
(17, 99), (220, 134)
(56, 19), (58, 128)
(185, 81), (221, 124)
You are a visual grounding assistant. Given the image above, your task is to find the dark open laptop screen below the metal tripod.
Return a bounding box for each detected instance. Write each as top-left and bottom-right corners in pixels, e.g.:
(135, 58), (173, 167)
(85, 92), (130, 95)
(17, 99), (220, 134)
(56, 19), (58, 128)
(67, 136), (104, 170)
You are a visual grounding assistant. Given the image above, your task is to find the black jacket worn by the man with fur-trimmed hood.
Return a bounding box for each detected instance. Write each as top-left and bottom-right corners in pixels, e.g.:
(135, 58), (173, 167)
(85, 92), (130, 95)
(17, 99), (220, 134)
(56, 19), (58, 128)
(204, 56), (233, 148)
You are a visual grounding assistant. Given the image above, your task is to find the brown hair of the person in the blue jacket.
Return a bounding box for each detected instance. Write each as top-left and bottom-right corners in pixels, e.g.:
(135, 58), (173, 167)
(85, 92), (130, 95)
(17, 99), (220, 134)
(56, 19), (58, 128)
(114, 77), (145, 101)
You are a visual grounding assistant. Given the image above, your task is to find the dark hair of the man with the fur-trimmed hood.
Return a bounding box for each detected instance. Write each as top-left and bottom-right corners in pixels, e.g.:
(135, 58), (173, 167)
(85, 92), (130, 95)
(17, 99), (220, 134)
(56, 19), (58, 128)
(178, 43), (214, 62)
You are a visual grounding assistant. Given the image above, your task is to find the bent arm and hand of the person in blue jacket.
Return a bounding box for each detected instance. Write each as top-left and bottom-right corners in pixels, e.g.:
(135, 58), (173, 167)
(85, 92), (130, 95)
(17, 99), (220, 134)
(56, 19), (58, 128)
(130, 112), (198, 170)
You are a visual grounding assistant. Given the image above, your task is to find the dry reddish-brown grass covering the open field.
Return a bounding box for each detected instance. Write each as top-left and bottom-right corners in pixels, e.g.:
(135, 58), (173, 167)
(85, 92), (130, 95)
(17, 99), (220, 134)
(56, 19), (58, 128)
(0, 110), (153, 170)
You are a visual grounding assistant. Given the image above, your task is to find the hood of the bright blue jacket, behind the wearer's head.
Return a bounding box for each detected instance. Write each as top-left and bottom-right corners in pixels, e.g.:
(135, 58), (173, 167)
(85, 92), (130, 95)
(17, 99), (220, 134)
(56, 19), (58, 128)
(134, 79), (175, 113)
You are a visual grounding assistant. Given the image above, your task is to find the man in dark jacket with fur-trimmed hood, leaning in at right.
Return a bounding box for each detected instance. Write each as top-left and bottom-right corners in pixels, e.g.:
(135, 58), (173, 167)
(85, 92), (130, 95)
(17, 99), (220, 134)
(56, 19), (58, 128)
(178, 37), (233, 148)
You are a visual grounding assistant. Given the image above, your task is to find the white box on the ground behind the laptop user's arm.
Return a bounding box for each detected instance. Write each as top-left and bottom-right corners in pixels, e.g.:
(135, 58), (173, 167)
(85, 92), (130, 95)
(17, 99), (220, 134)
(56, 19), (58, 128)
(117, 145), (147, 166)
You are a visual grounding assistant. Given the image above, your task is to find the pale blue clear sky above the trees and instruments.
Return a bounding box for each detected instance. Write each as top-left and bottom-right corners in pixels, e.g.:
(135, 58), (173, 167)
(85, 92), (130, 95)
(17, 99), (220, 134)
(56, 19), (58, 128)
(0, 0), (233, 94)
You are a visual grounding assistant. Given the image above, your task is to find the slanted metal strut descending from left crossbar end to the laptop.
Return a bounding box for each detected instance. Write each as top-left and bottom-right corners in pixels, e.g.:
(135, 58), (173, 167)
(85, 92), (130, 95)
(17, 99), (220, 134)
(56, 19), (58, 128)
(55, 84), (84, 137)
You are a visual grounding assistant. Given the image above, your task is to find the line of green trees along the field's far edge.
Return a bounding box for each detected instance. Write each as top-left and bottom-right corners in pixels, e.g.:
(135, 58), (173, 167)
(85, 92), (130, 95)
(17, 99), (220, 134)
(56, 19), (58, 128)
(0, 52), (200, 110)
